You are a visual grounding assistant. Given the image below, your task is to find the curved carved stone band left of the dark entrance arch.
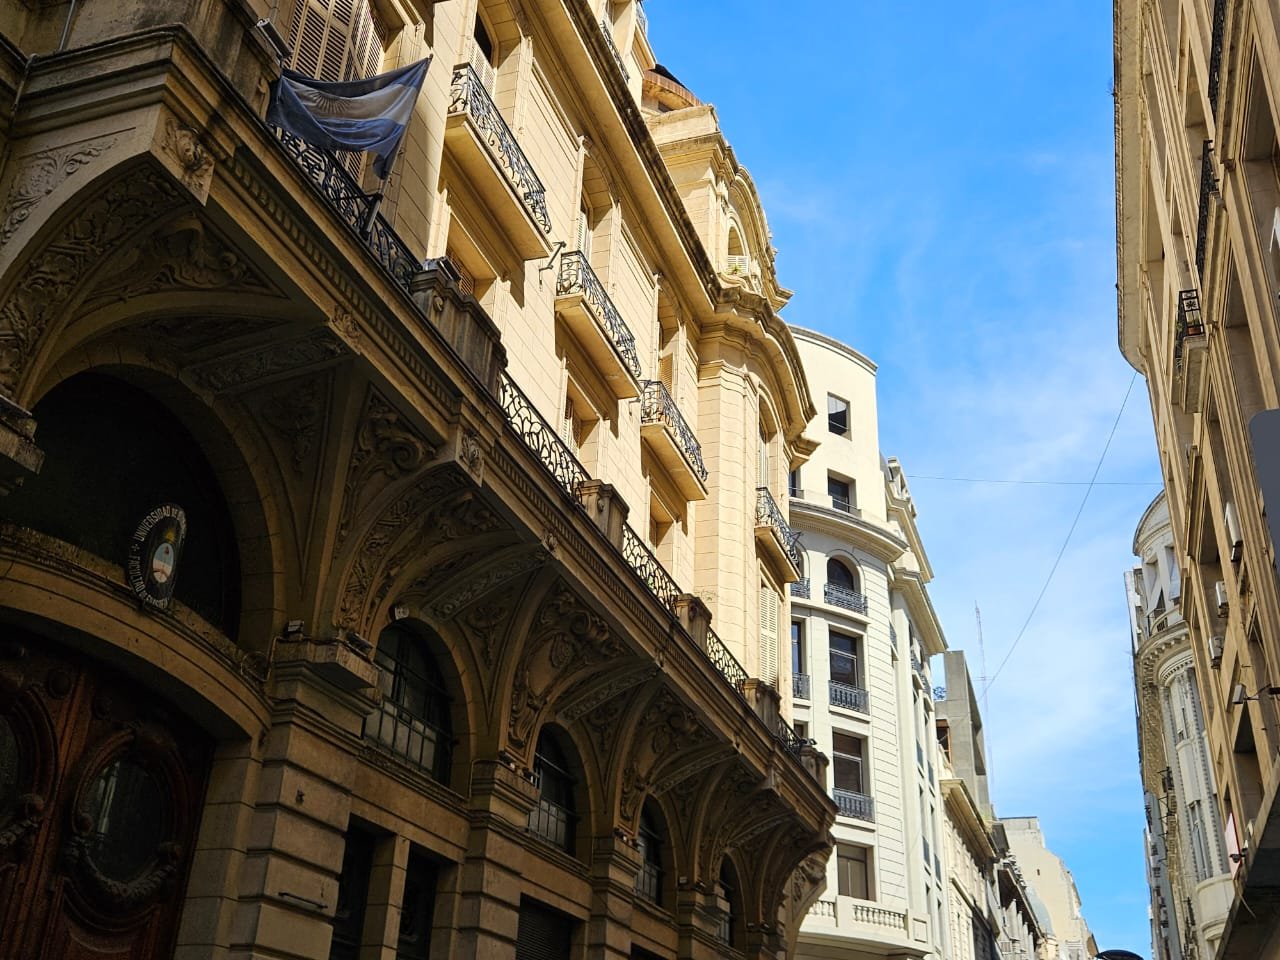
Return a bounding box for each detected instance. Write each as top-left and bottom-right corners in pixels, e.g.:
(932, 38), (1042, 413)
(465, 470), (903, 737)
(0, 169), (180, 402)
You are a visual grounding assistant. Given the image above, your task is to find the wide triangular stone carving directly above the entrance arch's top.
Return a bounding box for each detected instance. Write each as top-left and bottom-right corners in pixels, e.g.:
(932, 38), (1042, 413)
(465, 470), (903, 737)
(90, 216), (280, 301)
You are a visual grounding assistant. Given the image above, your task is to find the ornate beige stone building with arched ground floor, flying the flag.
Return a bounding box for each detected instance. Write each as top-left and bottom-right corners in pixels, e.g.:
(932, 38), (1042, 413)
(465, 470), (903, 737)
(0, 0), (834, 960)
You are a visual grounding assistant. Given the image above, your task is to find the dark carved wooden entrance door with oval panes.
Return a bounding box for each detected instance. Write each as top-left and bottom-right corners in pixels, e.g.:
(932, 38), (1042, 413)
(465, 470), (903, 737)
(0, 632), (210, 960)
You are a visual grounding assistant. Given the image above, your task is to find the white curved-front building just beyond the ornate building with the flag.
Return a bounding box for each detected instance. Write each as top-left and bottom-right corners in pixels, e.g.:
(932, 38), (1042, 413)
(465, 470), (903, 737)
(790, 328), (946, 957)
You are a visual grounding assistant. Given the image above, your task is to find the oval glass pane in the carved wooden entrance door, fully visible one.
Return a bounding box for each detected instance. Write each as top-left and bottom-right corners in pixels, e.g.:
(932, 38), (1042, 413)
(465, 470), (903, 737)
(86, 760), (165, 882)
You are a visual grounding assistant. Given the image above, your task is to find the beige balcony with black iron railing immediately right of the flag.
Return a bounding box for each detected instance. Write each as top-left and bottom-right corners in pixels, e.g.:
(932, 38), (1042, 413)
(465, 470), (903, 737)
(444, 63), (552, 260)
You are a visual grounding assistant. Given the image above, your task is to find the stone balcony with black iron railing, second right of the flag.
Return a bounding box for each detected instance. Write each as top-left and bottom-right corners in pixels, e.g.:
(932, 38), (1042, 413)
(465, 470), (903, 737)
(556, 250), (640, 399)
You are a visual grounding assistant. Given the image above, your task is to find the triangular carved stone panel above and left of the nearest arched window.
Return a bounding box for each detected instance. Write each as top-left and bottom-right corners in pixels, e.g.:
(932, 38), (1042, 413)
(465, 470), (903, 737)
(338, 388), (435, 547)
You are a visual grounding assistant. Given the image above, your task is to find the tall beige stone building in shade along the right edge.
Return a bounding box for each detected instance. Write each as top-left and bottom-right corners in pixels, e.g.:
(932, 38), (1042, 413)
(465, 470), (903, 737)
(1115, 0), (1280, 959)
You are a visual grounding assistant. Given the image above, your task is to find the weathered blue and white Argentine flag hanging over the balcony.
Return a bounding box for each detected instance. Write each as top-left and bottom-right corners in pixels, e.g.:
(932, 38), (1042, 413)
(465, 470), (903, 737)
(266, 56), (431, 179)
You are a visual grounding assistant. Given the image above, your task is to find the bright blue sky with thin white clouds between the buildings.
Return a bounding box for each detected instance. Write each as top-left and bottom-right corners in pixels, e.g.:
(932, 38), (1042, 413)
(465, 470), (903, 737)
(646, 0), (1160, 956)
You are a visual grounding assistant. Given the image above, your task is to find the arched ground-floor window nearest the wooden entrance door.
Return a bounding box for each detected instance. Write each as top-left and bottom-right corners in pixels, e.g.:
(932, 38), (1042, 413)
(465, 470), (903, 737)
(365, 623), (453, 783)
